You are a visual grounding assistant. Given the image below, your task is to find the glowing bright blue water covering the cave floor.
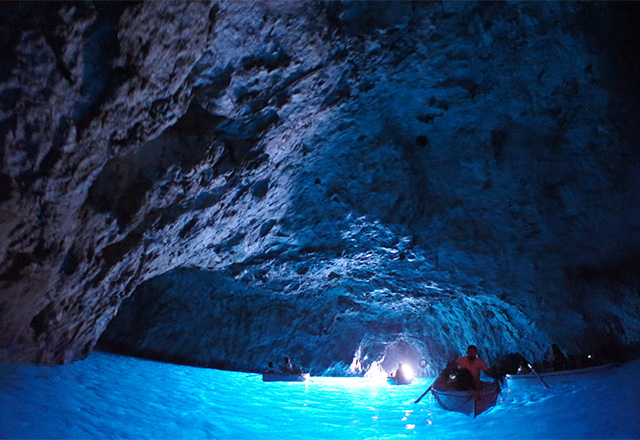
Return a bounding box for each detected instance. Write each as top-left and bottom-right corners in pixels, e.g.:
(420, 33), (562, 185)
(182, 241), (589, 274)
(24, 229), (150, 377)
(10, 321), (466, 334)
(0, 353), (640, 440)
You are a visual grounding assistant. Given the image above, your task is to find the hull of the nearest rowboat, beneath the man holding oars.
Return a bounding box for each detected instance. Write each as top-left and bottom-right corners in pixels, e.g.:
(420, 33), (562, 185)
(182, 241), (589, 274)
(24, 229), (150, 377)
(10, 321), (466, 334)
(431, 379), (500, 417)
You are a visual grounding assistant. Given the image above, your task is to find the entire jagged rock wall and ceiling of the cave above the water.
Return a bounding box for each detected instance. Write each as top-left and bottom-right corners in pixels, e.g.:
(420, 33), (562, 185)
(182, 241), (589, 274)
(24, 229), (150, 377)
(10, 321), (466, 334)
(0, 1), (640, 374)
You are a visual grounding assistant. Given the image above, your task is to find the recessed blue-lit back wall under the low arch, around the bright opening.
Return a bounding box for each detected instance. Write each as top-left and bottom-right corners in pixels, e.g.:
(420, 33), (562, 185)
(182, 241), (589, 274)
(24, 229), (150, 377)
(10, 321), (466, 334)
(101, 266), (548, 375)
